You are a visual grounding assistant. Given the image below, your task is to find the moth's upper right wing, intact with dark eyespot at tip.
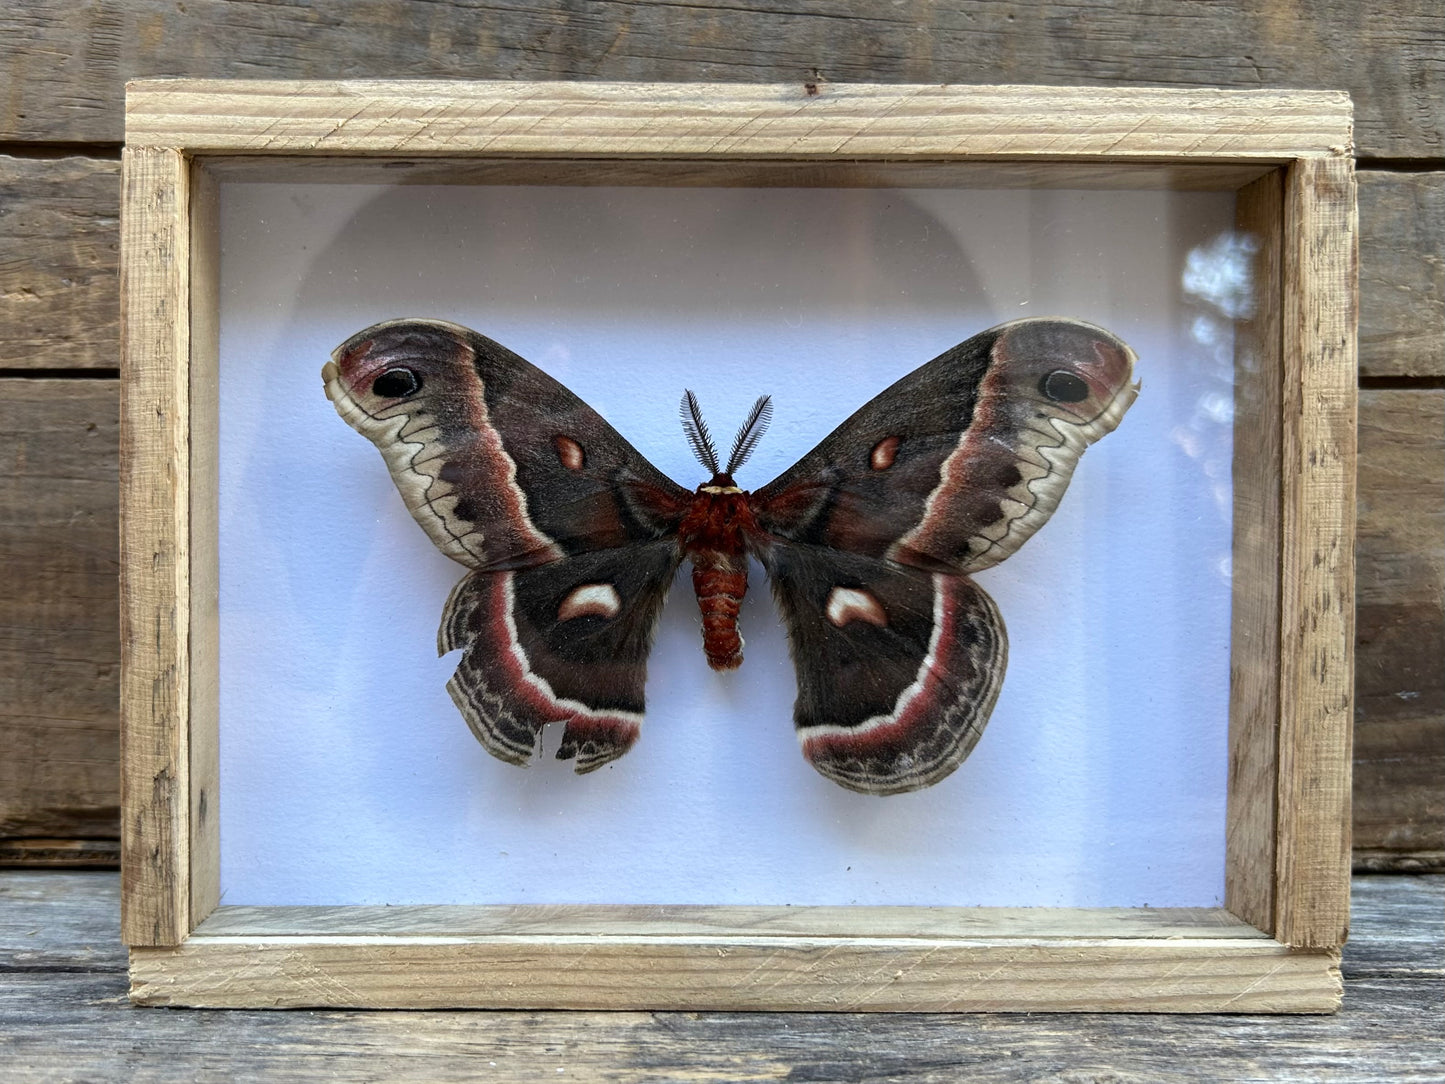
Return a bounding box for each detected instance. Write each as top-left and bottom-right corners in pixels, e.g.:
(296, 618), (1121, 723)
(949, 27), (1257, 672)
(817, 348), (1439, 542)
(753, 319), (1136, 574)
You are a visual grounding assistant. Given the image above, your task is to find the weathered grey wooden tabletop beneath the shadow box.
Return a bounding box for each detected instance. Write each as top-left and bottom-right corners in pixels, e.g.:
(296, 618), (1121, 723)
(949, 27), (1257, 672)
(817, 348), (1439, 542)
(0, 872), (1445, 1084)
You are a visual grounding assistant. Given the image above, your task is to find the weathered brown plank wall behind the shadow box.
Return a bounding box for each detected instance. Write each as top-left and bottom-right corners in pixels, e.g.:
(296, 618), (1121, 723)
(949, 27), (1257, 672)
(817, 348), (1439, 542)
(0, 0), (1445, 870)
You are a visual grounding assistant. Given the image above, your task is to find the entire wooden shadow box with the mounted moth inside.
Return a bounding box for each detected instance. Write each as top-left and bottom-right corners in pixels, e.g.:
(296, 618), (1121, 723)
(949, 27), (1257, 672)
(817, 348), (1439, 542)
(124, 82), (1354, 1010)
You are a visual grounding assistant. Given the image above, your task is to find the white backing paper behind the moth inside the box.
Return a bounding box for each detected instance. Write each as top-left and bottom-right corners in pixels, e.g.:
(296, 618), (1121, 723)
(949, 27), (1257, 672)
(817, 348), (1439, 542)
(220, 184), (1247, 906)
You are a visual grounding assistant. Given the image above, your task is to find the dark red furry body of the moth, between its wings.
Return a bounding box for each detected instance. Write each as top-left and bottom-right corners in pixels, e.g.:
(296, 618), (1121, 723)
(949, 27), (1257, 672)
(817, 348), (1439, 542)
(678, 478), (757, 671)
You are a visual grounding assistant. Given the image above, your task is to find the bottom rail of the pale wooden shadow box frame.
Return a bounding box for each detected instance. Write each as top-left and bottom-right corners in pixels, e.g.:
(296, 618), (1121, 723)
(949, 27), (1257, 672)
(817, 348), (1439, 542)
(133, 906), (1337, 1012)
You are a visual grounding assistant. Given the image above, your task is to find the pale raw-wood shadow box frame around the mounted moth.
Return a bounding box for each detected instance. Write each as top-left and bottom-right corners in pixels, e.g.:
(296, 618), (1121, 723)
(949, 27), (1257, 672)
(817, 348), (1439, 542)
(121, 81), (1357, 1012)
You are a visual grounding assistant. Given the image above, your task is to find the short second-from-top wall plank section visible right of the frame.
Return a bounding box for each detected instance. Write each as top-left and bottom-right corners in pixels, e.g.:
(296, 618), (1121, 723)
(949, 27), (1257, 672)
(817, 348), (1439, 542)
(1360, 172), (1445, 377)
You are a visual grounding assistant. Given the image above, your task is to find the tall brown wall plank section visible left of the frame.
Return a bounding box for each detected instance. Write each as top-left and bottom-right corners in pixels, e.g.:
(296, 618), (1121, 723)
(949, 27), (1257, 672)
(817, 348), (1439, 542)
(0, 379), (120, 861)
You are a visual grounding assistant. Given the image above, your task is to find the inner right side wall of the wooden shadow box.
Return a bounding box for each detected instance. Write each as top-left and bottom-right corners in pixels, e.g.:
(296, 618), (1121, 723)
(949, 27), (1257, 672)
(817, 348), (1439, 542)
(1224, 171), (1285, 932)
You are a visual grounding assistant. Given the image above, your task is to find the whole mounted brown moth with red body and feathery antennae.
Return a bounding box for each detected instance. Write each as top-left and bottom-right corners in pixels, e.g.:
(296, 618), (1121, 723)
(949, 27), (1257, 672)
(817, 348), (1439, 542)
(322, 319), (1137, 795)
